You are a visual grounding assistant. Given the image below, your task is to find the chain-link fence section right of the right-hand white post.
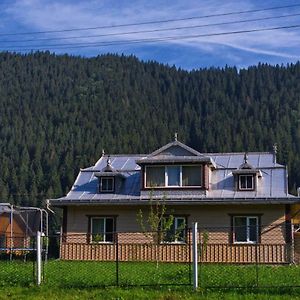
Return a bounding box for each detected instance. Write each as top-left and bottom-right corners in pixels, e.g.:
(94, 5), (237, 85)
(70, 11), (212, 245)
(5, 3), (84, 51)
(198, 223), (300, 288)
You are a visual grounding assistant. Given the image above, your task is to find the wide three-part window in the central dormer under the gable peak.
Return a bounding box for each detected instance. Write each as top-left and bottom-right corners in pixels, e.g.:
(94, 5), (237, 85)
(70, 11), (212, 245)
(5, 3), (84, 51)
(145, 165), (202, 188)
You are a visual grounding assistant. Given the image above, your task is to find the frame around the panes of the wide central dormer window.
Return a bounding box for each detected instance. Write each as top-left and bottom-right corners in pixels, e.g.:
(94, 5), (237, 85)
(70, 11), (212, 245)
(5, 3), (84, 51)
(144, 165), (203, 188)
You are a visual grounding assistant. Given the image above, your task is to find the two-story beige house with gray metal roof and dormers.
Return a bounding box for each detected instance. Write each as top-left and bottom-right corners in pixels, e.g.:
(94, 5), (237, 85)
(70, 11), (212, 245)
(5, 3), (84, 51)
(50, 138), (299, 263)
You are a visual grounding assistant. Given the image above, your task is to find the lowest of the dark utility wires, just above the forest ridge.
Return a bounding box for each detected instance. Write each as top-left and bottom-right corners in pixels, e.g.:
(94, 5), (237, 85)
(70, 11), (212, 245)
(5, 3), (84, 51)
(1, 24), (300, 51)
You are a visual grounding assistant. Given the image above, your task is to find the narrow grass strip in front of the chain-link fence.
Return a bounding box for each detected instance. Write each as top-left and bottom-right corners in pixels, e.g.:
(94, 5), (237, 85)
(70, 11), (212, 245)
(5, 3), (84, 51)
(0, 286), (300, 300)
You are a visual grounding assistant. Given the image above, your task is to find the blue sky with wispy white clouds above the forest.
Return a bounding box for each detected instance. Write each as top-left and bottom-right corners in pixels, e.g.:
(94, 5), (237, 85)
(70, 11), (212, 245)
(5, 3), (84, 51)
(0, 0), (300, 70)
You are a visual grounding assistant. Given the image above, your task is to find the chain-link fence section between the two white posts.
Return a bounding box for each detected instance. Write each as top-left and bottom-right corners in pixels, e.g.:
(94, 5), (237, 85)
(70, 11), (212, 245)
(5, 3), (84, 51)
(44, 230), (191, 287)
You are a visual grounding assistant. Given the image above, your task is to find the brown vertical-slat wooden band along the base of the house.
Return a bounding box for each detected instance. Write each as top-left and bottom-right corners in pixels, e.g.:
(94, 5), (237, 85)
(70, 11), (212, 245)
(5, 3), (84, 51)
(60, 242), (290, 264)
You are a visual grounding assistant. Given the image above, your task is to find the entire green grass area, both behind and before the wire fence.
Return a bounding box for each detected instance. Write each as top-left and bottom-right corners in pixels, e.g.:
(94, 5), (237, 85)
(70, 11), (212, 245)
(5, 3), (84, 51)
(0, 260), (300, 299)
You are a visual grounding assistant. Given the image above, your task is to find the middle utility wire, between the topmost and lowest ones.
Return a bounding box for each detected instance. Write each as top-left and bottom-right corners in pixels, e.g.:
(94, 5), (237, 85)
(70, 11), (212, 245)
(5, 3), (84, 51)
(0, 13), (300, 43)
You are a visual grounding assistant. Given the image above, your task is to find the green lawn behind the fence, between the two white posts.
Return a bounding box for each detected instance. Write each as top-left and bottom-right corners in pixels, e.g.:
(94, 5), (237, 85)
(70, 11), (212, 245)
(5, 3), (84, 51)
(45, 261), (191, 287)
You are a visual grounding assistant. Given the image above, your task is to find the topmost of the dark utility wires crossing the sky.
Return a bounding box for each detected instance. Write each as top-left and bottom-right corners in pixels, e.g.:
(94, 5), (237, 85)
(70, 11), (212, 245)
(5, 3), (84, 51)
(0, 4), (300, 36)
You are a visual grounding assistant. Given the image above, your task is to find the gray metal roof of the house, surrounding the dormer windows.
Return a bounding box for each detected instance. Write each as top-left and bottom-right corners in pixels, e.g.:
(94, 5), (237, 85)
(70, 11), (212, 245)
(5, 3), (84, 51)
(50, 141), (299, 205)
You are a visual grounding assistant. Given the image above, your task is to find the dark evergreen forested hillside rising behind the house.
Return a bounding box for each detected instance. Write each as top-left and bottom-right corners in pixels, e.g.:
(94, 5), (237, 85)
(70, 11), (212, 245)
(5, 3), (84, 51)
(0, 53), (300, 205)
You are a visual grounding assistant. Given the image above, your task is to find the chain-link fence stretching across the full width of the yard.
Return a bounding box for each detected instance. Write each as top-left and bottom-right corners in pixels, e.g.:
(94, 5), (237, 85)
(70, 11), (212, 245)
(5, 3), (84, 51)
(0, 226), (300, 288)
